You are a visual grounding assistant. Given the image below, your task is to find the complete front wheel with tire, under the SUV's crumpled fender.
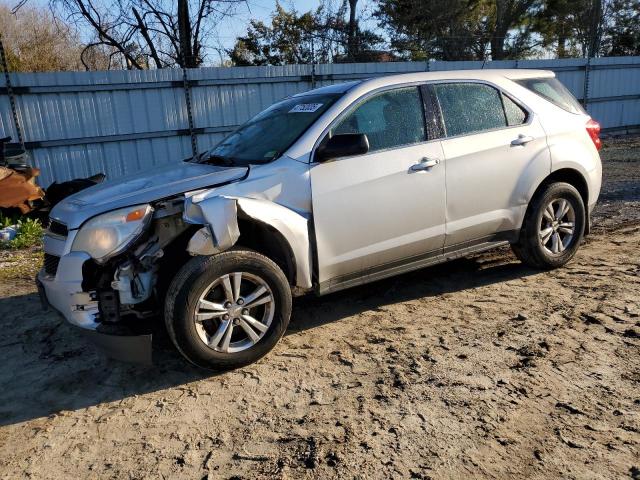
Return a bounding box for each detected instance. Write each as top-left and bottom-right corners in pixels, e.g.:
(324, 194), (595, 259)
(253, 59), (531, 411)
(165, 250), (291, 370)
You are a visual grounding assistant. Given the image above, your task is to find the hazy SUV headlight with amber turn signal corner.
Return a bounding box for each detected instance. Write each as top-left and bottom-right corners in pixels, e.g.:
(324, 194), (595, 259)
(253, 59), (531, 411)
(71, 205), (153, 263)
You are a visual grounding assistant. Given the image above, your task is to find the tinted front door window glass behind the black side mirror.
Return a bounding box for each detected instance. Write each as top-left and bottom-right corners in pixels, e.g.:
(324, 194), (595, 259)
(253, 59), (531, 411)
(333, 87), (426, 151)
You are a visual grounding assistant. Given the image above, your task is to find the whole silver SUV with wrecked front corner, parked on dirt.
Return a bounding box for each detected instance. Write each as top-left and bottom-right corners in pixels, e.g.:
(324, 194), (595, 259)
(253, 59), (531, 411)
(38, 70), (602, 369)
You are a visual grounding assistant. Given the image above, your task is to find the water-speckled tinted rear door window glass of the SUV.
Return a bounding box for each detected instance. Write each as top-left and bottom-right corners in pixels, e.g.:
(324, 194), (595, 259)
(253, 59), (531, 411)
(433, 83), (507, 137)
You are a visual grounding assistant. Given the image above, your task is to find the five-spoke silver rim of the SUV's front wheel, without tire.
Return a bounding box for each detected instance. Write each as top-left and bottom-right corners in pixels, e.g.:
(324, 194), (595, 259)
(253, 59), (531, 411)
(193, 272), (275, 353)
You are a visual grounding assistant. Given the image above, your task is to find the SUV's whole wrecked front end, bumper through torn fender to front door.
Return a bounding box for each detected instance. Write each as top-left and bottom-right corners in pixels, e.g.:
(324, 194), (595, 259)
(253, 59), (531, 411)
(38, 165), (312, 363)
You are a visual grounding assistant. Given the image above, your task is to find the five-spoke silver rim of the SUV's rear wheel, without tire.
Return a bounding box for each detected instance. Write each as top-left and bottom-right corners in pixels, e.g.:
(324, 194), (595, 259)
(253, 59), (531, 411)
(538, 198), (576, 255)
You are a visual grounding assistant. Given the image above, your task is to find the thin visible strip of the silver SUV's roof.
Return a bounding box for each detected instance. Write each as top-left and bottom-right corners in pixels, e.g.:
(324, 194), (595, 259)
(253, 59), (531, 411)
(298, 69), (555, 95)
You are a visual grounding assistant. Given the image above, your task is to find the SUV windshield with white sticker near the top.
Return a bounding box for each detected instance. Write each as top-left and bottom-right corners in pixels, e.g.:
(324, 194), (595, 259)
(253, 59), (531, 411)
(196, 93), (342, 166)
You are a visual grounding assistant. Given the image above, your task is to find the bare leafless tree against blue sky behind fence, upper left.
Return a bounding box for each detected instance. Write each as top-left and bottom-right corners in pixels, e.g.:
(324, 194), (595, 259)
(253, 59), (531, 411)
(50, 0), (244, 69)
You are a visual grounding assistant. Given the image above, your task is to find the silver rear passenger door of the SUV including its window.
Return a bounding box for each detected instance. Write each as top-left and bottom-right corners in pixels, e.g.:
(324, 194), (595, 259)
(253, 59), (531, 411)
(430, 81), (550, 249)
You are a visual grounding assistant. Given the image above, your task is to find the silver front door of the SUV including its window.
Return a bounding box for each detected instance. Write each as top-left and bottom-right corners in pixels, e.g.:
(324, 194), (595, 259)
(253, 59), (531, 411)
(311, 86), (445, 292)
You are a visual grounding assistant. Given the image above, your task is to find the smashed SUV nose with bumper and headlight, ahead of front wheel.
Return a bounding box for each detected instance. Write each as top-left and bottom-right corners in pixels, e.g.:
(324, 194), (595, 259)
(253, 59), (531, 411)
(37, 197), (191, 364)
